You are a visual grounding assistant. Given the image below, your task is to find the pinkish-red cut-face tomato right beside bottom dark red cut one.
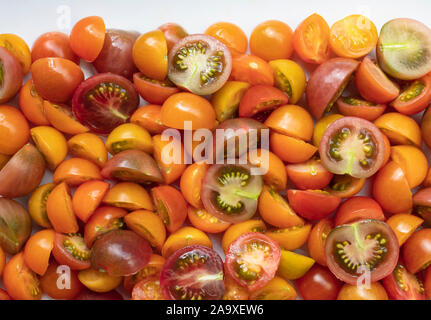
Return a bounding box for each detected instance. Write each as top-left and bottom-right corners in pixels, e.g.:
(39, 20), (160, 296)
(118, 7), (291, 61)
(225, 232), (281, 291)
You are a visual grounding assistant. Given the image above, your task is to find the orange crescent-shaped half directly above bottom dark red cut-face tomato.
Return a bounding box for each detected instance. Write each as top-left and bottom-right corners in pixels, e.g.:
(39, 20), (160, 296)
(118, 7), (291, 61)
(162, 227), (212, 258)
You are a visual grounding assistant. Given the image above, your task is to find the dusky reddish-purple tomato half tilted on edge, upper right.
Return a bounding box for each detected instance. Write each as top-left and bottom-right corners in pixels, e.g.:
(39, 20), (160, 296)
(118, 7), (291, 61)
(305, 58), (359, 119)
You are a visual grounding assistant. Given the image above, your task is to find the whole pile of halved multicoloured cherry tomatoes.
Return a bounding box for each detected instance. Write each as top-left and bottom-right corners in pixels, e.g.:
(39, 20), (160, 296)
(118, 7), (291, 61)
(0, 14), (431, 300)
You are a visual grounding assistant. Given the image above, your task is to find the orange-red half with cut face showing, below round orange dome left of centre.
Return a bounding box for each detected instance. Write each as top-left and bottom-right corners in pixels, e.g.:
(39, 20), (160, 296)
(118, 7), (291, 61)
(152, 135), (187, 184)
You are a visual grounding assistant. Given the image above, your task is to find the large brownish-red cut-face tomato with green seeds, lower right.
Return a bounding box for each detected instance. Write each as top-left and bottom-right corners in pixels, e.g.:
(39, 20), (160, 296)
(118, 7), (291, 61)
(325, 220), (399, 285)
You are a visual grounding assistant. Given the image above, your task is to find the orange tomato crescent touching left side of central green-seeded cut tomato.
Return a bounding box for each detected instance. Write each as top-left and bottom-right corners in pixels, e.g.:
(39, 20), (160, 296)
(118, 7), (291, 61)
(180, 161), (208, 208)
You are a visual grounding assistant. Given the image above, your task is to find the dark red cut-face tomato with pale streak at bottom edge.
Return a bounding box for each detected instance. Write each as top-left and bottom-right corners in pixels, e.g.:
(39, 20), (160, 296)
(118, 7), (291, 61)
(160, 246), (224, 300)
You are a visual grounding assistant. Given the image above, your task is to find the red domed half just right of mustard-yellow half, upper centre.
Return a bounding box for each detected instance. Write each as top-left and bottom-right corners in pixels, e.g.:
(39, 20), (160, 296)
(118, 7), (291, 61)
(239, 85), (289, 118)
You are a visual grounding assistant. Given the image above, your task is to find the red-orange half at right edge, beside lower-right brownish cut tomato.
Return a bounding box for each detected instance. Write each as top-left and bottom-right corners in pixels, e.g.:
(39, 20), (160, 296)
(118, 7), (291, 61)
(401, 228), (431, 274)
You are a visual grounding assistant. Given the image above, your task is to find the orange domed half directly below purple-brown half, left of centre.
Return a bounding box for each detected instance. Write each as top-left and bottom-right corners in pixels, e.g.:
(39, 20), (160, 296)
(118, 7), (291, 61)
(103, 182), (154, 211)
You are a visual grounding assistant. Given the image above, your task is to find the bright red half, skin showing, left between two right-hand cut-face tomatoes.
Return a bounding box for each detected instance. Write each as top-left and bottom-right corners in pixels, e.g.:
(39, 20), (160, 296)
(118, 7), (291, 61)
(287, 190), (341, 220)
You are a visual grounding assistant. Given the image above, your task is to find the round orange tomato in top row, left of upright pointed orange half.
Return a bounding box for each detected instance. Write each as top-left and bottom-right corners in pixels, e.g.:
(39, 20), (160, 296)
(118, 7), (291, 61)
(250, 20), (293, 61)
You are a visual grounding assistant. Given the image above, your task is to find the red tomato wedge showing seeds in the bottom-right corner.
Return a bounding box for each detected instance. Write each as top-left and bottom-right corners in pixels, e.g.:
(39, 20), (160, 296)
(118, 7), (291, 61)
(382, 263), (426, 300)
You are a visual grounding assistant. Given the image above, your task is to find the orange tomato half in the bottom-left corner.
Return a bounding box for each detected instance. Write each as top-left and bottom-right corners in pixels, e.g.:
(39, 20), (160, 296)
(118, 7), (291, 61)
(3, 252), (42, 300)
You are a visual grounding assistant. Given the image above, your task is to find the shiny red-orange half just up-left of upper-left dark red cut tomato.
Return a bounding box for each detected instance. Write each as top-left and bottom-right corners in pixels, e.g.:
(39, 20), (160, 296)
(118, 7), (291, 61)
(31, 58), (84, 103)
